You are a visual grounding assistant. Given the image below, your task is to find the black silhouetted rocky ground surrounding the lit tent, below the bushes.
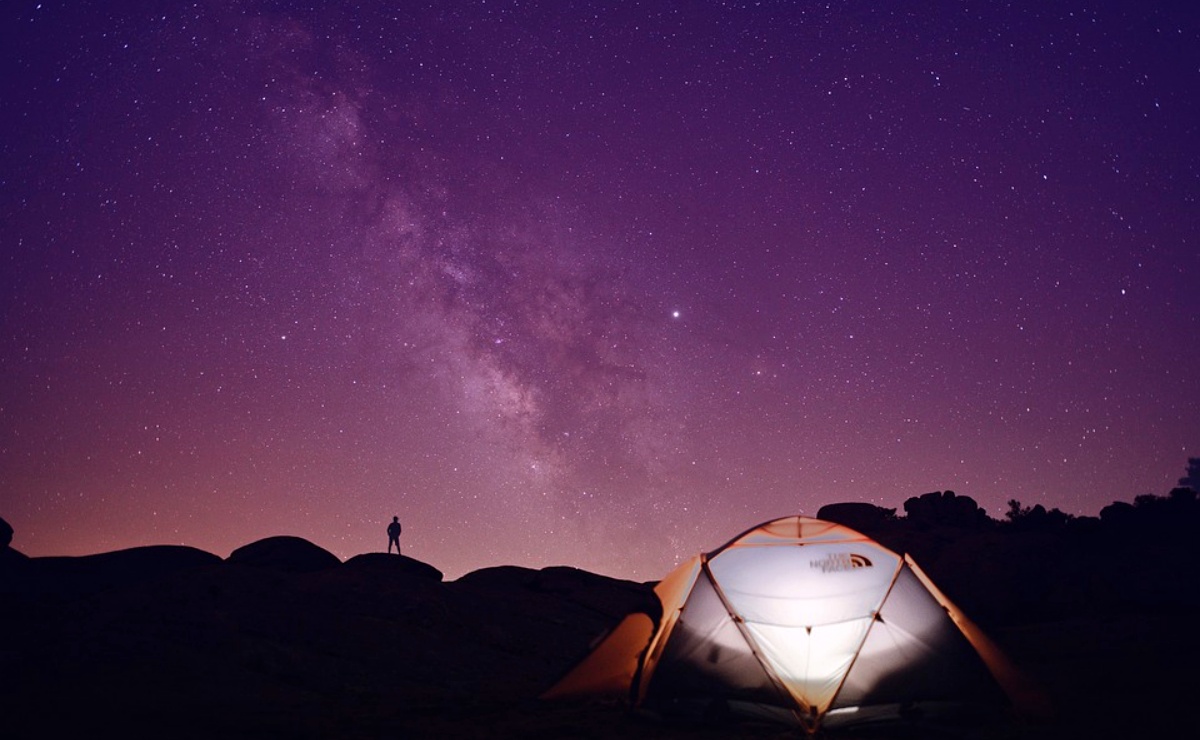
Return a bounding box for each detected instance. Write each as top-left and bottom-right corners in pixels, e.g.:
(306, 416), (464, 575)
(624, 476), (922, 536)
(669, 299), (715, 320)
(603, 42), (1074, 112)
(0, 513), (1200, 739)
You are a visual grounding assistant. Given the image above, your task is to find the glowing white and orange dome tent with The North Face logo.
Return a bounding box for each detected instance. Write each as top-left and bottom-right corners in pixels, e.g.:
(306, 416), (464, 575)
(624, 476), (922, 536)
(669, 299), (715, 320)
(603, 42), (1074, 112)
(544, 517), (1041, 734)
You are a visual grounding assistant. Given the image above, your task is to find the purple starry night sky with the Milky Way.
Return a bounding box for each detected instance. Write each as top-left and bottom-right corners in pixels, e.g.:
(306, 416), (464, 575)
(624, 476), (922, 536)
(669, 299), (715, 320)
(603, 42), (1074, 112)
(0, 0), (1200, 579)
